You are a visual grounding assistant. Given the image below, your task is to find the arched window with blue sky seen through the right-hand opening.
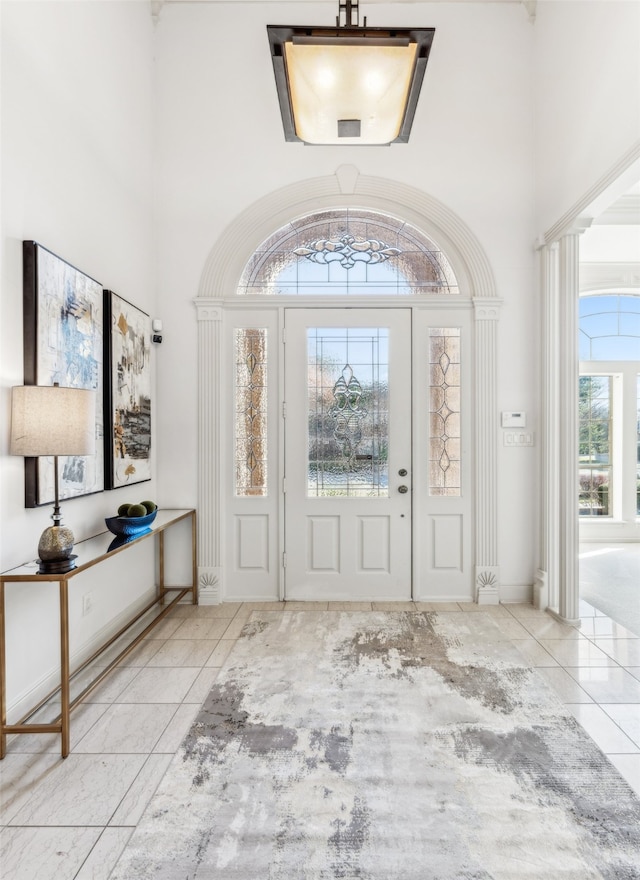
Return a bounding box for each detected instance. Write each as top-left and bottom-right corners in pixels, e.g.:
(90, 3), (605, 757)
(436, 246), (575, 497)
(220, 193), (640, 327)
(579, 293), (640, 521)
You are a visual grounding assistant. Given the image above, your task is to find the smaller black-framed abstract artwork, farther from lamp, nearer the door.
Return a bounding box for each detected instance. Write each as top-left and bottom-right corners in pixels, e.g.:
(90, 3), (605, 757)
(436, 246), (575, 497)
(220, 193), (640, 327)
(104, 290), (151, 489)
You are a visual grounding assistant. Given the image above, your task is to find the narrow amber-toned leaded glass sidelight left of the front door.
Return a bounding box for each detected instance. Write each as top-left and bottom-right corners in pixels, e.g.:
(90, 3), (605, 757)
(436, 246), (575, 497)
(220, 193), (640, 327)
(235, 327), (267, 497)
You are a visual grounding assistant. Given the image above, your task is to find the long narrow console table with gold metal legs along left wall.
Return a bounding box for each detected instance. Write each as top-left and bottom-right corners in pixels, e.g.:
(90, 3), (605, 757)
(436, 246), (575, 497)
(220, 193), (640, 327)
(0, 510), (198, 760)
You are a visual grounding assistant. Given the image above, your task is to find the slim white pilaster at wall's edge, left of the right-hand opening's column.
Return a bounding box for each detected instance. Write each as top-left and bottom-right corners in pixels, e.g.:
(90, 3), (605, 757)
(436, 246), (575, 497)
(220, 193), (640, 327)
(533, 243), (560, 612)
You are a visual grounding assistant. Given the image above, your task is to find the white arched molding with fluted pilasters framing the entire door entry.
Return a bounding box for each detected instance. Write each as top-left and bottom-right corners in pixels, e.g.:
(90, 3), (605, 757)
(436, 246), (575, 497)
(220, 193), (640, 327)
(196, 166), (501, 603)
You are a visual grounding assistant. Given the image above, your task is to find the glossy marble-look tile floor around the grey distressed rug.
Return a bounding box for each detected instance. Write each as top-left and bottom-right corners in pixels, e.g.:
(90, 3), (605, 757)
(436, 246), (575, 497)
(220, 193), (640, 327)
(0, 602), (640, 880)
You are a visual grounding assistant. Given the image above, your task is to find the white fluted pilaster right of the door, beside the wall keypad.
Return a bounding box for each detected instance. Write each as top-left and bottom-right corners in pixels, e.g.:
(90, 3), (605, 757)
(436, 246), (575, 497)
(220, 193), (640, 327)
(473, 297), (500, 605)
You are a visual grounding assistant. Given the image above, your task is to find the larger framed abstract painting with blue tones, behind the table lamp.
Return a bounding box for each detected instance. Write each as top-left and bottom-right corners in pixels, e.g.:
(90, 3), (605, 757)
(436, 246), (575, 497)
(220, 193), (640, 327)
(22, 241), (104, 507)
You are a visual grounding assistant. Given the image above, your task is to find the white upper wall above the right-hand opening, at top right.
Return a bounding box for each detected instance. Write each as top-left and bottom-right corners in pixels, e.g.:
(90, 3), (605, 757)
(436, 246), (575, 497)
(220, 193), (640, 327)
(535, 0), (640, 233)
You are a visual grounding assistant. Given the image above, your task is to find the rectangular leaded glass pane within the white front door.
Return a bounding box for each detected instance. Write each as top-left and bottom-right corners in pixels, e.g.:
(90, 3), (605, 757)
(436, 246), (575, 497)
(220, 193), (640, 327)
(307, 327), (389, 498)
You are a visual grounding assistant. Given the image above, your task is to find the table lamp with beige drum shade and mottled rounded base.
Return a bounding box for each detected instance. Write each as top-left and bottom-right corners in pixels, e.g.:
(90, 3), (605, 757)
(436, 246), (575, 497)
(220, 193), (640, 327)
(10, 383), (96, 574)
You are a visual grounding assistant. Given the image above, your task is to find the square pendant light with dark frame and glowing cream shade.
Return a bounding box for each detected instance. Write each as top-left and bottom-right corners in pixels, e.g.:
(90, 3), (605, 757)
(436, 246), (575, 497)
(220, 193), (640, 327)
(267, 0), (435, 145)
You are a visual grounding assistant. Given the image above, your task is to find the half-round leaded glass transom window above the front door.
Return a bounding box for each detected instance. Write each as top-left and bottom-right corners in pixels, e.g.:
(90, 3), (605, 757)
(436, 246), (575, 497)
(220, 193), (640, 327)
(237, 208), (459, 296)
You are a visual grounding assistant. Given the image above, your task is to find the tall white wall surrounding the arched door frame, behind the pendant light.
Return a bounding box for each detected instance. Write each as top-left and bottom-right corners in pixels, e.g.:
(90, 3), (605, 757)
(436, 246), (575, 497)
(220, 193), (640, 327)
(156, 2), (535, 585)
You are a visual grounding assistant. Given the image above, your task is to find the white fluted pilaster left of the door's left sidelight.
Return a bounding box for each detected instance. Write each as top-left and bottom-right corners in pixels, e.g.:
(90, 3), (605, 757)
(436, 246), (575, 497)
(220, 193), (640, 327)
(196, 298), (222, 605)
